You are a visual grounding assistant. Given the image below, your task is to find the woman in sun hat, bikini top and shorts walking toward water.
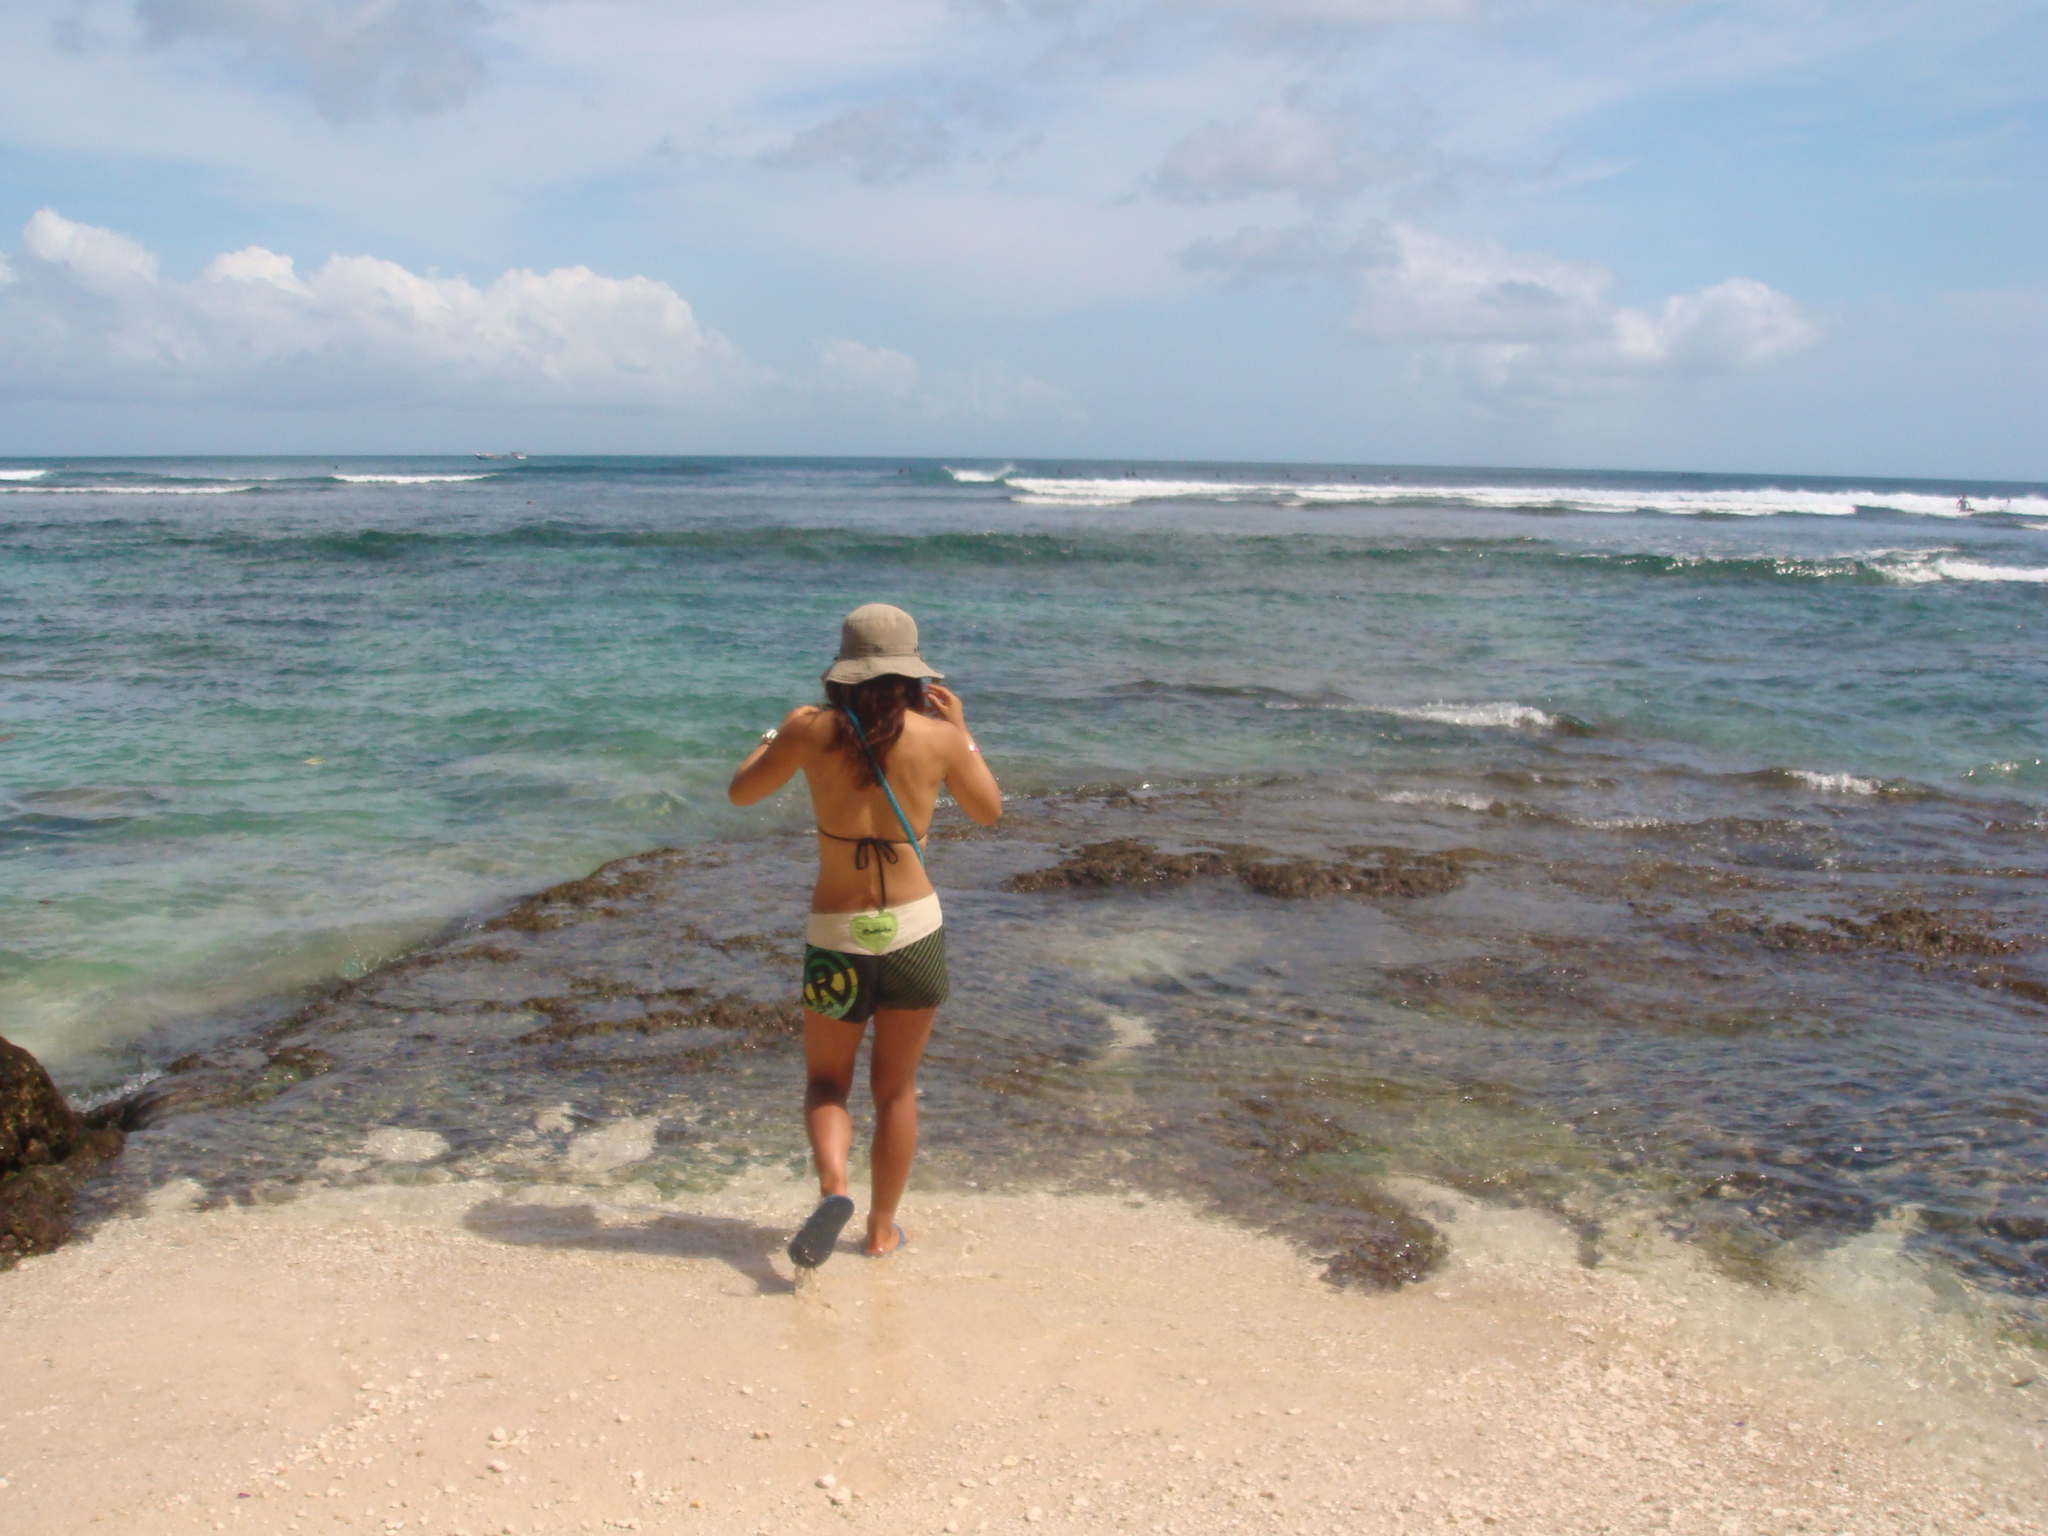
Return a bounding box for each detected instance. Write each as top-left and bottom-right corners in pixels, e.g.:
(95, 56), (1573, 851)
(727, 602), (1004, 1268)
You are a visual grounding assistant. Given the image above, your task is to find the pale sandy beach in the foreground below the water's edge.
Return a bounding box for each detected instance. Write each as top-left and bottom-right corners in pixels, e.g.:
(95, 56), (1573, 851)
(0, 1176), (2048, 1536)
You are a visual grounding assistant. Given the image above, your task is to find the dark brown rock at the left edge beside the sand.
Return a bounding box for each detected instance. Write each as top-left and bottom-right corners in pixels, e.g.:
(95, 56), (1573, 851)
(0, 1038), (121, 1270)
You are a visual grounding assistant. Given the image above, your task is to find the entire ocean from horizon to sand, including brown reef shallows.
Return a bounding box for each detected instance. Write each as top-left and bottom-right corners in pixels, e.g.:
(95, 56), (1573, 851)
(0, 457), (2048, 1317)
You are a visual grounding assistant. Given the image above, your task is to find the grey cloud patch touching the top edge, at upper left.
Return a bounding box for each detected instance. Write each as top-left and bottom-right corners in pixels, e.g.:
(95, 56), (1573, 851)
(135, 0), (492, 123)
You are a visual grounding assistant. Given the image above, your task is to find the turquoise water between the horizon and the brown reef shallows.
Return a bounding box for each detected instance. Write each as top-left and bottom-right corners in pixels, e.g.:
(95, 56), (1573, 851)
(0, 459), (2048, 1092)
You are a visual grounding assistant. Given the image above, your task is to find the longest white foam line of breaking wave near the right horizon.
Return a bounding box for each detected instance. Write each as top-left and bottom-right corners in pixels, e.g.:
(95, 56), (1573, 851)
(1008, 477), (2048, 518)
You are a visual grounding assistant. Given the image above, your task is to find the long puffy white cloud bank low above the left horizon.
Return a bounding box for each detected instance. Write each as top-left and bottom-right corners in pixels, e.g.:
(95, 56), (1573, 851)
(0, 209), (1073, 422)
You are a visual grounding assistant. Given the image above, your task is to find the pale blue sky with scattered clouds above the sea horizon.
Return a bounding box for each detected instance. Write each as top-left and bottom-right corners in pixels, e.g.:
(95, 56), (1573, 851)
(0, 0), (2048, 479)
